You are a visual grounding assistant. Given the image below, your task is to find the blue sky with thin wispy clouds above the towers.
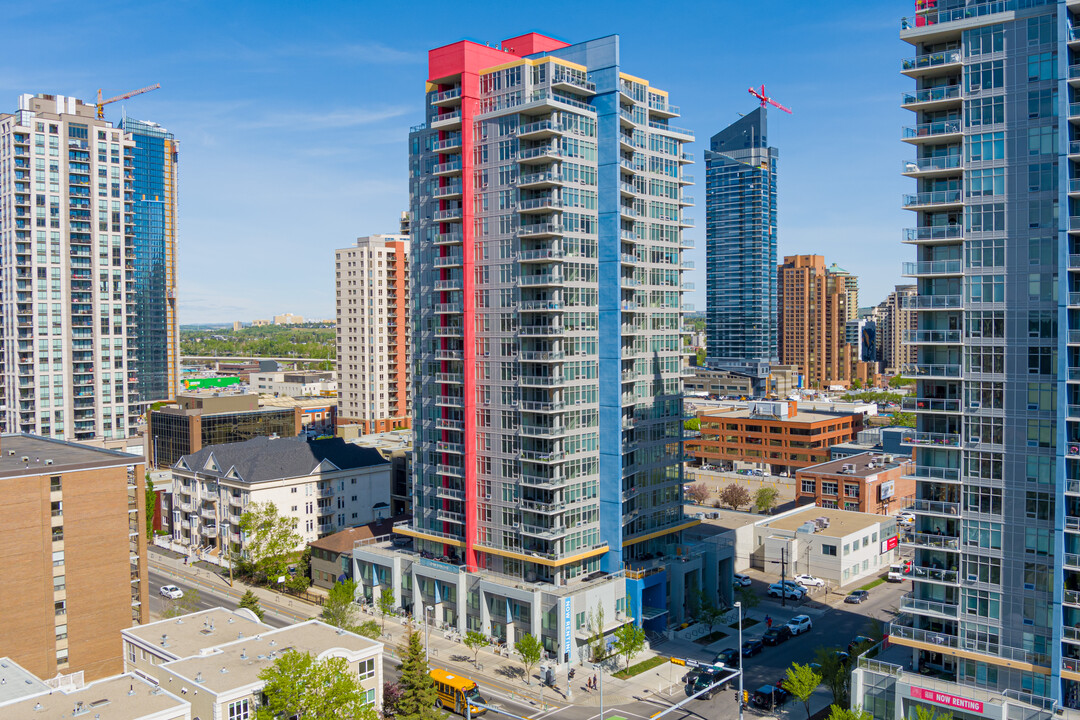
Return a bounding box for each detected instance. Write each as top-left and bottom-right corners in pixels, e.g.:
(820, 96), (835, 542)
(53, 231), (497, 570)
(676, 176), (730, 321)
(8, 0), (914, 323)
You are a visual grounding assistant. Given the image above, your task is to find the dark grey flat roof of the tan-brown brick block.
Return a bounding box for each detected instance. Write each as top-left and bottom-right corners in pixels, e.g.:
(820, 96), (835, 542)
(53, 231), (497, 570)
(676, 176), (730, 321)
(0, 433), (143, 478)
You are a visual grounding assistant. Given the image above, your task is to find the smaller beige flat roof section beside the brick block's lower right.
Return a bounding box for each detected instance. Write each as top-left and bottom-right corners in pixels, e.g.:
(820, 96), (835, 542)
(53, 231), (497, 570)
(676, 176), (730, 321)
(123, 608), (273, 657)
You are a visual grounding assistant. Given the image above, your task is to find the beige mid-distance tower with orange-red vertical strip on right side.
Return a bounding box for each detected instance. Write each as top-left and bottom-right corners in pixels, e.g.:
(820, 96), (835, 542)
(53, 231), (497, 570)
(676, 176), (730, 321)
(335, 234), (411, 435)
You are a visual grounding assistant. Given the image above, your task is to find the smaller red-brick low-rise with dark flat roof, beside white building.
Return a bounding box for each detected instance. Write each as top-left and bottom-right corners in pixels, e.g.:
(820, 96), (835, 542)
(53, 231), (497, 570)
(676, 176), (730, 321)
(795, 452), (915, 515)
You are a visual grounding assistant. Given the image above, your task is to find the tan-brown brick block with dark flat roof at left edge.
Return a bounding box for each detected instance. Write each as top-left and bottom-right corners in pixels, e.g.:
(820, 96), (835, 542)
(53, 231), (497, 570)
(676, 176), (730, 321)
(0, 435), (149, 680)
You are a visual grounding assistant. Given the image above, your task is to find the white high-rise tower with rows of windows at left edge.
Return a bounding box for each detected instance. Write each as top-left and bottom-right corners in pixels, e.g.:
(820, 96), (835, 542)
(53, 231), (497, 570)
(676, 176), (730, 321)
(0, 95), (151, 440)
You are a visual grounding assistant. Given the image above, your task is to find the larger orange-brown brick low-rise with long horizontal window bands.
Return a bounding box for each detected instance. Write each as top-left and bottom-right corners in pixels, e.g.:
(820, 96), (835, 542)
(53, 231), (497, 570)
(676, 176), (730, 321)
(686, 400), (863, 473)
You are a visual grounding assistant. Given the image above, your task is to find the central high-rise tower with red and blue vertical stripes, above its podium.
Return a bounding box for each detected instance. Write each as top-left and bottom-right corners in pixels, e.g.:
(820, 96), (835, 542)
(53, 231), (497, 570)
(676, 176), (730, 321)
(397, 33), (700, 634)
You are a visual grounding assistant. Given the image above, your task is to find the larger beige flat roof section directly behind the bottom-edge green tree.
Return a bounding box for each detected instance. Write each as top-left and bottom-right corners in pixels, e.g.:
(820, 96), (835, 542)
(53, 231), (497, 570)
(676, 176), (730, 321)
(159, 620), (382, 694)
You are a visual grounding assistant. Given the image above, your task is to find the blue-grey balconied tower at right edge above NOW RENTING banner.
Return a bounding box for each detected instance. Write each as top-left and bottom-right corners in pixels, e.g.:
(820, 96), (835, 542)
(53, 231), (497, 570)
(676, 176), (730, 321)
(852, 0), (1080, 718)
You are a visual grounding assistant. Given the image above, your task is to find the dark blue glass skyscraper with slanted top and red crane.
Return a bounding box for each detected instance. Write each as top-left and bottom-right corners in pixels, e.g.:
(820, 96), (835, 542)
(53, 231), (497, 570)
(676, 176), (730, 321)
(705, 108), (779, 389)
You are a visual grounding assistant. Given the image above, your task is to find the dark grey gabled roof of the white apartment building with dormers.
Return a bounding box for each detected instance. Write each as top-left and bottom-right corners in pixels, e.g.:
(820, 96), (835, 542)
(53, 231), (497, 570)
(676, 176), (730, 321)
(173, 437), (390, 483)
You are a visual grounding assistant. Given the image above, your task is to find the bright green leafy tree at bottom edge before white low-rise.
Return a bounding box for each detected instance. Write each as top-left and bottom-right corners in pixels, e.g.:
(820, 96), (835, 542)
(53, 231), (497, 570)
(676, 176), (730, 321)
(255, 650), (377, 720)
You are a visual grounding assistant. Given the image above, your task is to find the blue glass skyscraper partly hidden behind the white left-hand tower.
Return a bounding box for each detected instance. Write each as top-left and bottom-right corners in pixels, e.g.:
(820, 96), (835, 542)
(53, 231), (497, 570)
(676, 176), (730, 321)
(120, 118), (179, 403)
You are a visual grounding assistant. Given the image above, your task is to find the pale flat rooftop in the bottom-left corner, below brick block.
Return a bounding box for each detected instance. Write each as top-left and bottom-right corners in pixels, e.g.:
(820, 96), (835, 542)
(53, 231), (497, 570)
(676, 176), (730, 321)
(0, 674), (191, 720)
